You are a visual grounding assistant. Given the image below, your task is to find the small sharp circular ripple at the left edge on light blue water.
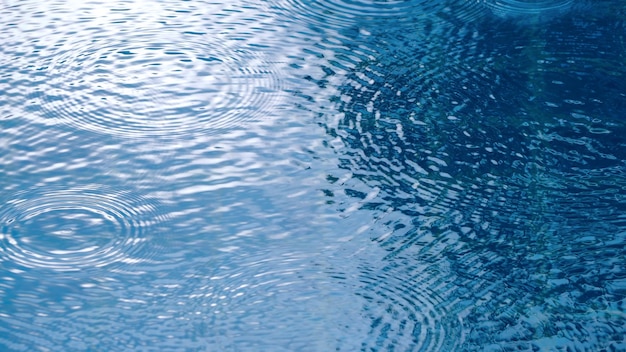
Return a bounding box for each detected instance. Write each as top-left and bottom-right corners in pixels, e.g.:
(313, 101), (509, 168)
(0, 186), (161, 271)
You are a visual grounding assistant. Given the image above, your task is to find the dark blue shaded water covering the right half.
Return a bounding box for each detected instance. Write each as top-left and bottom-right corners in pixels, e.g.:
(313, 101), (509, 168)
(308, 1), (626, 351)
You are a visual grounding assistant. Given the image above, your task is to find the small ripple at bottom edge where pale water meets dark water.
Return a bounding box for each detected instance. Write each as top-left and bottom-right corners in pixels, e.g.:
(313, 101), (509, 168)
(357, 260), (464, 351)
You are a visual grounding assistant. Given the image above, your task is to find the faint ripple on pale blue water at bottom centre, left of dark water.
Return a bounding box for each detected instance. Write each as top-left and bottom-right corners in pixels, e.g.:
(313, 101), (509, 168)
(145, 249), (366, 351)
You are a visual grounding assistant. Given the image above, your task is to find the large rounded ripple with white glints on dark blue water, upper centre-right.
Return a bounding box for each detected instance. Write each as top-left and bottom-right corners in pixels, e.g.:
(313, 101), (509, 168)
(322, 21), (528, 239)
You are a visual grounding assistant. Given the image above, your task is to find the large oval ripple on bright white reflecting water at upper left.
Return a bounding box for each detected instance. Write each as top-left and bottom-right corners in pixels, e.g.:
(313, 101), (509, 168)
(43, 31), (280, 137)
